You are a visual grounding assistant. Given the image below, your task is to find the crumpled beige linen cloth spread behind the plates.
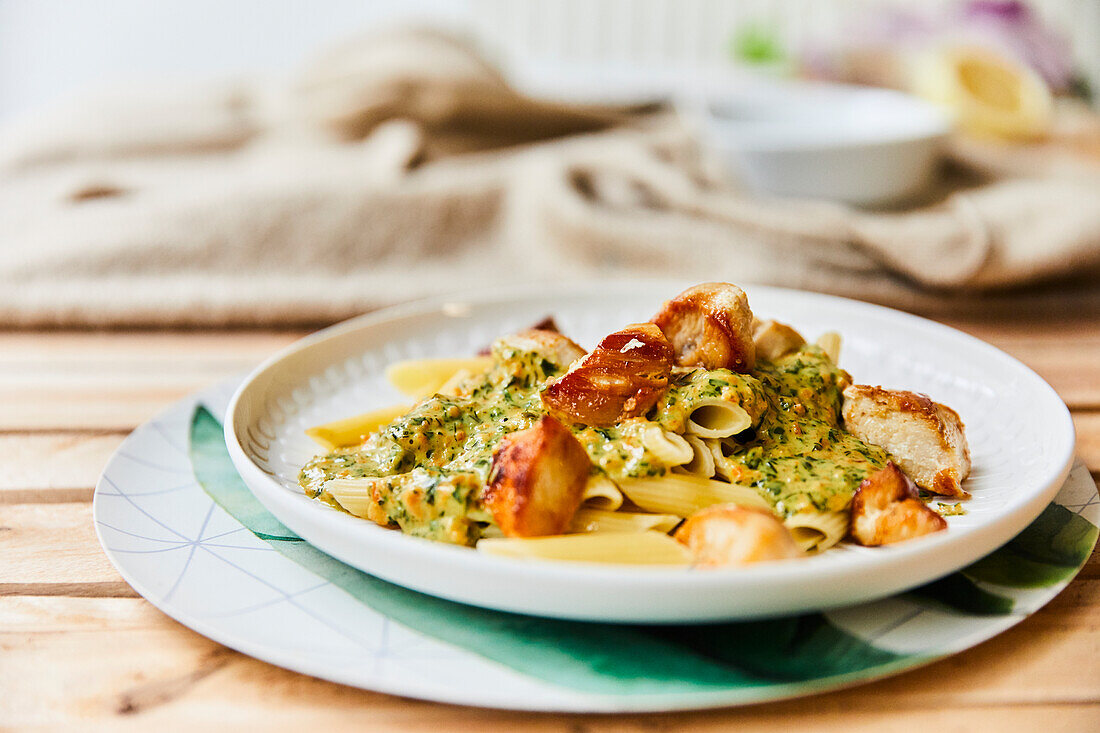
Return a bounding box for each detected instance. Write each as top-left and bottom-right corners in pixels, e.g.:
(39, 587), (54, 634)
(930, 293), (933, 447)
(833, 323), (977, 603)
(0, 31), (1100, 326)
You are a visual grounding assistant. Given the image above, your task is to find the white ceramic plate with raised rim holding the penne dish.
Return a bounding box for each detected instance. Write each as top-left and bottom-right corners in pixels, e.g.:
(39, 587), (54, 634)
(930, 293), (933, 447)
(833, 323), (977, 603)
(226, 281), (1075, 623)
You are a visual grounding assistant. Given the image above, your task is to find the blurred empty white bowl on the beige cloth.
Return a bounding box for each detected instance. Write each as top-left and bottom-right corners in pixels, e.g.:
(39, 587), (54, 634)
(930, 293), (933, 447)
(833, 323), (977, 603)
(694, 84), (950, 206)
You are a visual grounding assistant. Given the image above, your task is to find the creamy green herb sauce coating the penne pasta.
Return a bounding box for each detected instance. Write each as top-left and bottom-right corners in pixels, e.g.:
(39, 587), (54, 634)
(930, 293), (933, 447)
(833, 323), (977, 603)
(299, 341), (887, 545)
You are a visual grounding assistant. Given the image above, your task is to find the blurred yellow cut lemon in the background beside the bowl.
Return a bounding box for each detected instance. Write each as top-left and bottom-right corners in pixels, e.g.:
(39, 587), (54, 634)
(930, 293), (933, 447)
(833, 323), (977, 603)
(912, 47), (1054, 140)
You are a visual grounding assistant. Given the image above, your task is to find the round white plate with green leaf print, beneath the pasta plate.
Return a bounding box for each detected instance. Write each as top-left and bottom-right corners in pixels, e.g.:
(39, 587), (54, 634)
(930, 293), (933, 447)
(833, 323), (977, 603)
(94, 382), (1100, 712)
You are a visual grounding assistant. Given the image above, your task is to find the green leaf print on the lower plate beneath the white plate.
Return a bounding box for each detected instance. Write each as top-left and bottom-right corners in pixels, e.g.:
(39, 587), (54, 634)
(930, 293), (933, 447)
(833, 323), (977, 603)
(190, 406), (1098, 694)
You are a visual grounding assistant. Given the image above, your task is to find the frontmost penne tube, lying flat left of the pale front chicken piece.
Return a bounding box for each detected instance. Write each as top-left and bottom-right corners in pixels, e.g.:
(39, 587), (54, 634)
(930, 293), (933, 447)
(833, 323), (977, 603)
(477, 530), (691, 565)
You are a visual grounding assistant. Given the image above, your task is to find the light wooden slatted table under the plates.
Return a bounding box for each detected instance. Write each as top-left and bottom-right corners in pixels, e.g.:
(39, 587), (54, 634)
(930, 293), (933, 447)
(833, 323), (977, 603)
(0, 311), (1100, 732)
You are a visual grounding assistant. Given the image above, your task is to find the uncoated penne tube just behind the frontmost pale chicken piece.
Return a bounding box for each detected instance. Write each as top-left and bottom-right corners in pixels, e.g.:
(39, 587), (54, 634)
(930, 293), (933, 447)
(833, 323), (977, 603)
(618, 473), (771, 516)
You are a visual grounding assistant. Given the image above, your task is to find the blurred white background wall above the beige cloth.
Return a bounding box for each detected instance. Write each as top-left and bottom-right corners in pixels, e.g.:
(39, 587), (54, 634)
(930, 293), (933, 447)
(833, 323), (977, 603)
(0, 0), (1100, 120)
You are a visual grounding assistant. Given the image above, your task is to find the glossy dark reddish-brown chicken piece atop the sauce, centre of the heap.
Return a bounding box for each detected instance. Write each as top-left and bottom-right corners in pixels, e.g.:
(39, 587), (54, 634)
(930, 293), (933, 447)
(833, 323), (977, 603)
(542, 324), (672, 426)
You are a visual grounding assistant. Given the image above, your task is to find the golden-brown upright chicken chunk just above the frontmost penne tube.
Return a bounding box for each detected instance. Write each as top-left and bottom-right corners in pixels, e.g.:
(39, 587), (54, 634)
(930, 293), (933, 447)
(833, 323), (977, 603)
(482, 416), (591, 537)
